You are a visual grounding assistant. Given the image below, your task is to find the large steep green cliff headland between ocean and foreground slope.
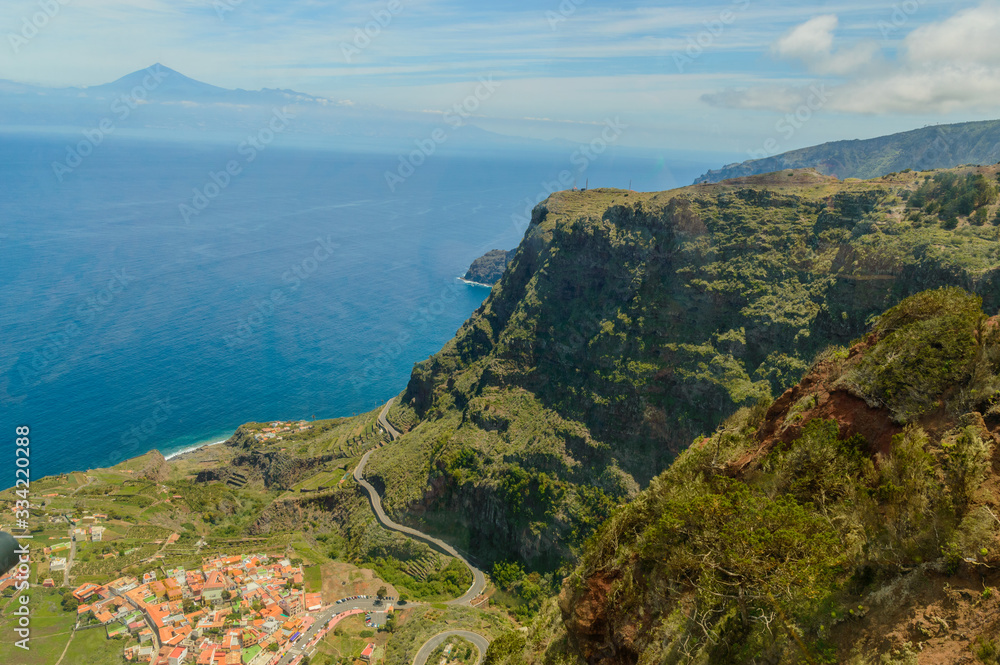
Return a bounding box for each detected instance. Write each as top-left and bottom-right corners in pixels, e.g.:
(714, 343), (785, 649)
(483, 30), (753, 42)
(367, 167), (1000, 566)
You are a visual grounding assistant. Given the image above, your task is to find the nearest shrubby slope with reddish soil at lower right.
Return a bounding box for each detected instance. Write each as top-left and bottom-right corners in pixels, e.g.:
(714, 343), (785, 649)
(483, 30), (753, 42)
(516, 288), (1000, 665)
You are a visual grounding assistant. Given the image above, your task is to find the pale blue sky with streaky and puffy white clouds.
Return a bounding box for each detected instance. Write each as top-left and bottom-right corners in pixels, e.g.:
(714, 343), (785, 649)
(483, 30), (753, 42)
(0, 0), (1000, 156)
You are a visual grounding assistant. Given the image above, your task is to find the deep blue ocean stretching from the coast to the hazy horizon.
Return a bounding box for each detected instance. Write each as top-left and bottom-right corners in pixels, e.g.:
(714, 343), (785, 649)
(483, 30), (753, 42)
(0, 134), (714, 486)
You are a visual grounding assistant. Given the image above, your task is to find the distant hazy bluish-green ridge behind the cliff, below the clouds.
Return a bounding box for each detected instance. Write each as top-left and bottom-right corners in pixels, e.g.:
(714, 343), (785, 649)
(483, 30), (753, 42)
(695, 120), (1000, 183)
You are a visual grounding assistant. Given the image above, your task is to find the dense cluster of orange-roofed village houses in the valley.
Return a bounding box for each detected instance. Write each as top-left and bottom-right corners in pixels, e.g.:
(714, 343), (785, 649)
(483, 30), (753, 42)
(0, 554), (393, 665)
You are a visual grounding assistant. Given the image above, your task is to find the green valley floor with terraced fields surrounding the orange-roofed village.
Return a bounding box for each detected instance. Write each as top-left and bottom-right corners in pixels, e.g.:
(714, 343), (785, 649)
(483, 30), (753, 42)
(0, 415), (510, 665)
